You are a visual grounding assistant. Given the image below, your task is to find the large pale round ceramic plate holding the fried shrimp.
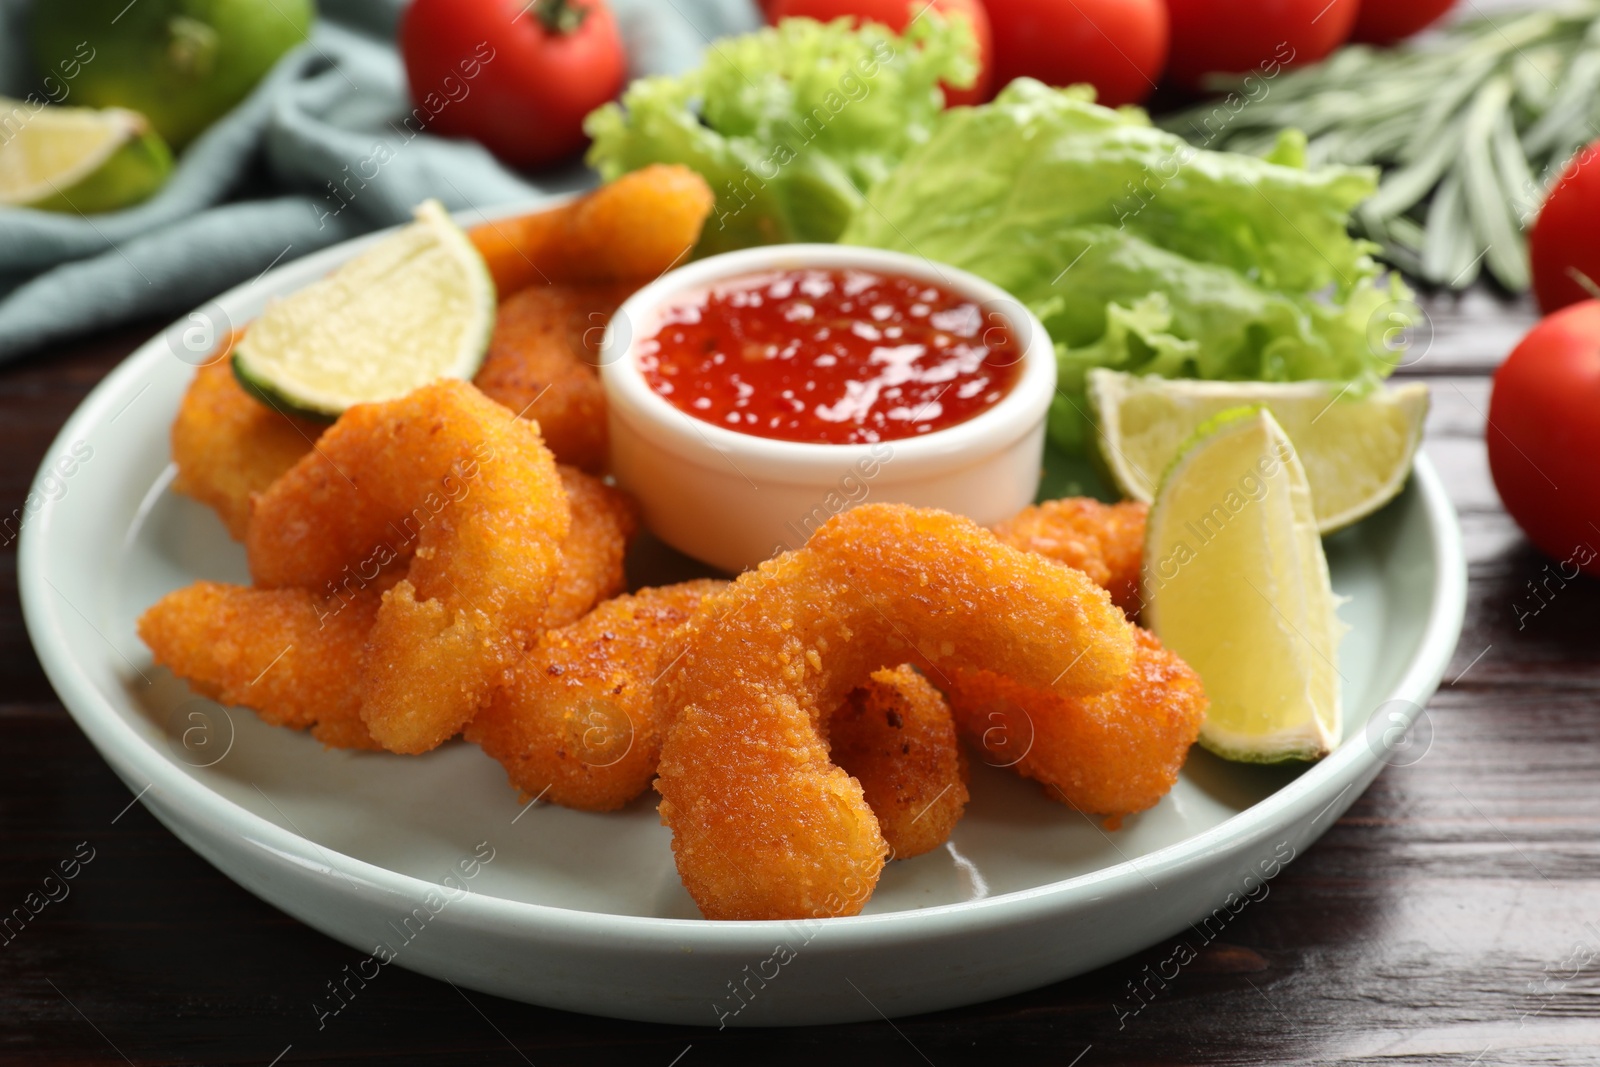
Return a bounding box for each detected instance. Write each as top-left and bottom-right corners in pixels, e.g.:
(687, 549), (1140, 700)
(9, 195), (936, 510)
(19, 214), (1466, 1025)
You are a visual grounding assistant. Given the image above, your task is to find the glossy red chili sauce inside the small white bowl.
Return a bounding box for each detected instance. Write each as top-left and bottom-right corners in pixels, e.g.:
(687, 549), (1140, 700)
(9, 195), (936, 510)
(638, 269), (1022, 445)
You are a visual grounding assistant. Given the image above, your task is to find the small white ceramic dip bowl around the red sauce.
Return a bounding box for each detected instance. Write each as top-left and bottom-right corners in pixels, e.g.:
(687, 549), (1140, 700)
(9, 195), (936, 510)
(600, 245), (1056, 571)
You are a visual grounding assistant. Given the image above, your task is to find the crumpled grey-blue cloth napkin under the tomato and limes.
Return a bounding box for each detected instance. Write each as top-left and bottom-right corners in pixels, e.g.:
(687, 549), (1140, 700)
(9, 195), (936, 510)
(0, 0), (760, 360)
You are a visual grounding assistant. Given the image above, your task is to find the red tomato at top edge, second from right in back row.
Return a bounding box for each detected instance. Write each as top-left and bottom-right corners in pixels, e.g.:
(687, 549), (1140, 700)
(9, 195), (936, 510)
(1166, 0), (1350, 90)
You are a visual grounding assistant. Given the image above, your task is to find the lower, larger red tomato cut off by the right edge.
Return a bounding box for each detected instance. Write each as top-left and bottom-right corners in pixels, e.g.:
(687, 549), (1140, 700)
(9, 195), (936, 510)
(1485, 301), (1600, 577)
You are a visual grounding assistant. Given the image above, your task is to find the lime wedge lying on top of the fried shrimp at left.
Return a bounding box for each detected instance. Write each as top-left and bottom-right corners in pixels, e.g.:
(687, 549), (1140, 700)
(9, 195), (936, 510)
(234, 200), (494, 419)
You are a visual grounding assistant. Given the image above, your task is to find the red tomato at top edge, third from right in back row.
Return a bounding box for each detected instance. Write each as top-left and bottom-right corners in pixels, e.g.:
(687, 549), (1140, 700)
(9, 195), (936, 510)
(986, 0), (1170, 107)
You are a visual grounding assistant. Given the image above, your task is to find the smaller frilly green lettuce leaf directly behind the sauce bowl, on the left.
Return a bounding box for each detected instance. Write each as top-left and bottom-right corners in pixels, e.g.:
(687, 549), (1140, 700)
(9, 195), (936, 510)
(584, 11), (976, 254)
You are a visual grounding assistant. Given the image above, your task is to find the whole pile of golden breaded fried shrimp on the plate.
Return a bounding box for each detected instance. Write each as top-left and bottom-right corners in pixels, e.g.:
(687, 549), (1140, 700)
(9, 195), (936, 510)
(138, 165), (1206, 920)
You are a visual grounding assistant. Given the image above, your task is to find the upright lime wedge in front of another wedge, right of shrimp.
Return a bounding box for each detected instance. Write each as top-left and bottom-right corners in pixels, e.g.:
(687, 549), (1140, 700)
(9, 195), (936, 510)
(1144, 408), (1344, 763)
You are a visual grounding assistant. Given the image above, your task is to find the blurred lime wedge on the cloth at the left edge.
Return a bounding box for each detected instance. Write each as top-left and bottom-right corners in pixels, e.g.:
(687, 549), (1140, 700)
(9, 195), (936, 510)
(0, 96), (173, 214)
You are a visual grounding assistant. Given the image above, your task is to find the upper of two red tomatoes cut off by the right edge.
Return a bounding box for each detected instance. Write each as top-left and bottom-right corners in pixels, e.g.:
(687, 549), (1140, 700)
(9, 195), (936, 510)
(1528, 141), (1600, 313)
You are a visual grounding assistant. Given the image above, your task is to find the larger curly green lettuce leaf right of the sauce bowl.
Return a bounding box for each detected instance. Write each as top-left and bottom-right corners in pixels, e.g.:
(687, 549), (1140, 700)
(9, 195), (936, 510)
(842, 78), (1418, 451)
